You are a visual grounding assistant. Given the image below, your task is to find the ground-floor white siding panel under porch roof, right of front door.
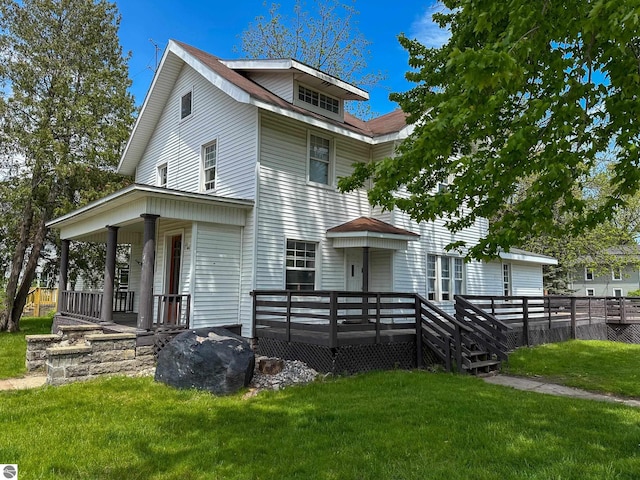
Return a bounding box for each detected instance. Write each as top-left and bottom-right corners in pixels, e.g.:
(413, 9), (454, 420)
(191, 223), (242, 328)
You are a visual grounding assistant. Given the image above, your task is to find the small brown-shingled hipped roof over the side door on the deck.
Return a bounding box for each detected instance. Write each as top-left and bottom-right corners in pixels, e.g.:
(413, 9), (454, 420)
(327, 217), (420, 250)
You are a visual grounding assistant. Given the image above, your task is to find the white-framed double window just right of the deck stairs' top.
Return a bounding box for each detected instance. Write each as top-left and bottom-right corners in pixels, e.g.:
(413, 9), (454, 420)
(427, 254), (464, 301)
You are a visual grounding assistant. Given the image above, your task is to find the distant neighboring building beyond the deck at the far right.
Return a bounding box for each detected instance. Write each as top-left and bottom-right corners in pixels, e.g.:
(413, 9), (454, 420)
(569, 247), (640, 297)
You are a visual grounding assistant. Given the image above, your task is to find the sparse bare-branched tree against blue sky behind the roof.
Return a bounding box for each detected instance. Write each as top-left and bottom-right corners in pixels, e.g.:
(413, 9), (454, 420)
(241, 0), (384, 114)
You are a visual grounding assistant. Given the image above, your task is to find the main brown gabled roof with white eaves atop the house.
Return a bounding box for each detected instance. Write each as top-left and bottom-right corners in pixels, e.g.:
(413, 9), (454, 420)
(118, 40), (410, 175)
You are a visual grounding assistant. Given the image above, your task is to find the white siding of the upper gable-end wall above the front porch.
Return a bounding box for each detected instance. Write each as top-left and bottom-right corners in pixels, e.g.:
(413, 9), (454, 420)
(136, 66), (257, 198)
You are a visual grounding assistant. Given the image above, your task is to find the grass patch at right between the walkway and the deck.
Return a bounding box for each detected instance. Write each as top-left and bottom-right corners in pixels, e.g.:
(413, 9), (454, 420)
(503, 340), (640, 398)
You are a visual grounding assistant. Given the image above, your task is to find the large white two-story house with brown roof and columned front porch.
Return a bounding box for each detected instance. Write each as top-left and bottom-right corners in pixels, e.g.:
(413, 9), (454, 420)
(50, 41), (556, 335)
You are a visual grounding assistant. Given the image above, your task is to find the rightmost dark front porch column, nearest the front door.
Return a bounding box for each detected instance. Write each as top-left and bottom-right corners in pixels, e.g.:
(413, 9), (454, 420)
(138, 213), (159, 331)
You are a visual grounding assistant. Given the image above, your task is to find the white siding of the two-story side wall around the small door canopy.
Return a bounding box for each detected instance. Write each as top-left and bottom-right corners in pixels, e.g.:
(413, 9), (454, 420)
(256, 114), (371, 290)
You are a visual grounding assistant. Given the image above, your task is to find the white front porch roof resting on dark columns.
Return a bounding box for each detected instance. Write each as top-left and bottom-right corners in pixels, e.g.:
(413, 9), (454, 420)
(47, 184), (254, 243)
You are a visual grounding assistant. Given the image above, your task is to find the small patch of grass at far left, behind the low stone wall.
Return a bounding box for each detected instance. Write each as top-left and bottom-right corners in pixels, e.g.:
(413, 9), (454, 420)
(0, 317), (53, 380)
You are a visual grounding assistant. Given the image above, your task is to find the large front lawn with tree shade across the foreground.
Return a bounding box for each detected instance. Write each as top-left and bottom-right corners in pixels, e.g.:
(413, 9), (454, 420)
(0, 371), (640, 480)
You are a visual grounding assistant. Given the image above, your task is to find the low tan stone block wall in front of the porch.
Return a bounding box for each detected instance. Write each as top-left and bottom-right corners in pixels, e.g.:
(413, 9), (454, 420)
(26, 325), (155, 385)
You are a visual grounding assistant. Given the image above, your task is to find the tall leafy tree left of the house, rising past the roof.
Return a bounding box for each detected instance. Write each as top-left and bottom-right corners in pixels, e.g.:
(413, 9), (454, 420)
(0, 0), (134, 331)
